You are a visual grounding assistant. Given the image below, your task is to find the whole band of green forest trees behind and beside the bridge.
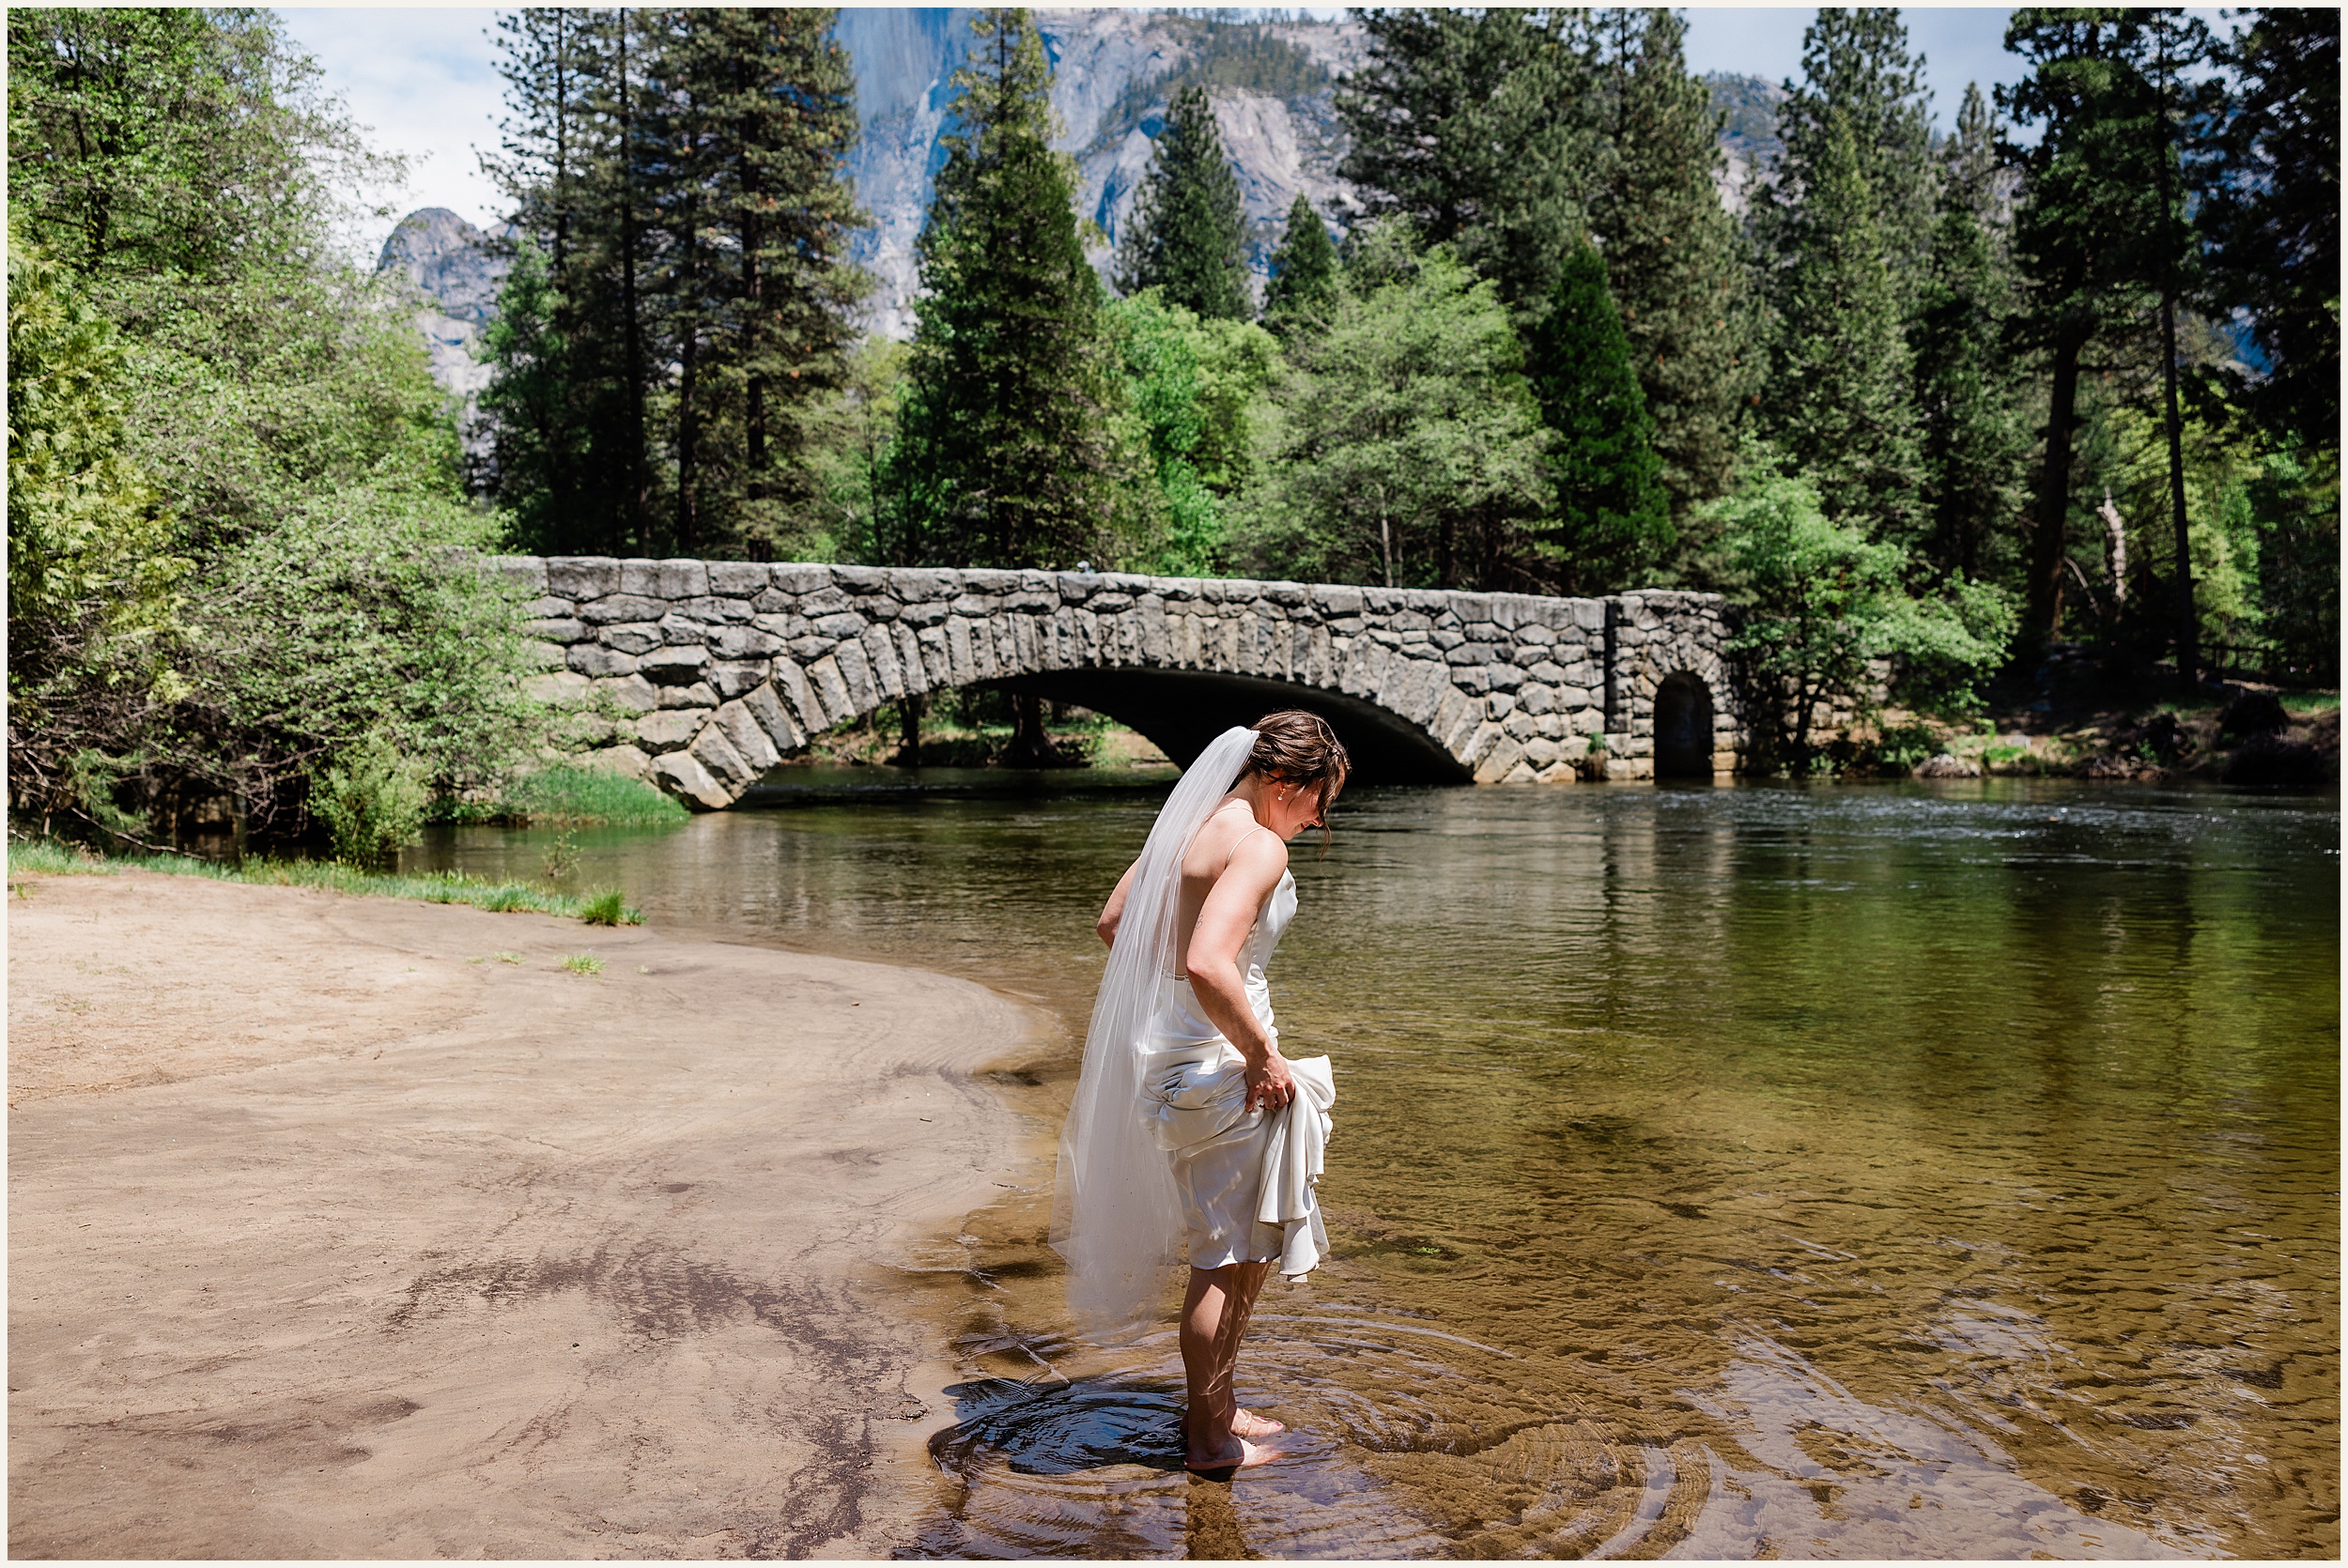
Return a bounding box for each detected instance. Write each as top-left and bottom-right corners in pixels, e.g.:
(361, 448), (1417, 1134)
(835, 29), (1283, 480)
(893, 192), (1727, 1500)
(9, 8), (2339, 836)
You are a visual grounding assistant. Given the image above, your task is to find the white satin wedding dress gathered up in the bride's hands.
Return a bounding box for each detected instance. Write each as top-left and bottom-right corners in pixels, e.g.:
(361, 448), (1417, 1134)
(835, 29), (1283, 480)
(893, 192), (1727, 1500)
(1141, 871), (1336, 1280)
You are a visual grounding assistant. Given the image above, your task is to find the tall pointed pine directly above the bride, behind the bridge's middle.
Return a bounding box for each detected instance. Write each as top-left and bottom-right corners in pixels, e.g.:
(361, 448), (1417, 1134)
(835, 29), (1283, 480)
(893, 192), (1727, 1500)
(897, 9), (1120, 566)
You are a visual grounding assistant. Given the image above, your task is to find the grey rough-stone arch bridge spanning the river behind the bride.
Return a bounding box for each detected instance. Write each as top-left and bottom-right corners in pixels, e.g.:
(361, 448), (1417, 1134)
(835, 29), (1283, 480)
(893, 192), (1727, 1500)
(493, 557), (1745, 810)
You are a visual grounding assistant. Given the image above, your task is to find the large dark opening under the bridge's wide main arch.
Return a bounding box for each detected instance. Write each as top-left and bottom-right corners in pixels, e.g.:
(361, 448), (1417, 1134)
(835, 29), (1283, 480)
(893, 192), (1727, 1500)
(1003, 669), (1470, 784)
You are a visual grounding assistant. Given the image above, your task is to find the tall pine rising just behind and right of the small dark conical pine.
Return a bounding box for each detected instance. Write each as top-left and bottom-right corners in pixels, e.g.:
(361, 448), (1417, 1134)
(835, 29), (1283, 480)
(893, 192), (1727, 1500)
(1592, 9), (1759, 519)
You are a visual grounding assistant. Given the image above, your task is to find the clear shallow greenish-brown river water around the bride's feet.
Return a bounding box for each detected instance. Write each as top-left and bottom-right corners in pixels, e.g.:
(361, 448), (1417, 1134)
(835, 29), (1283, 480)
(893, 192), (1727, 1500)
(425, 770), (2341, 1557)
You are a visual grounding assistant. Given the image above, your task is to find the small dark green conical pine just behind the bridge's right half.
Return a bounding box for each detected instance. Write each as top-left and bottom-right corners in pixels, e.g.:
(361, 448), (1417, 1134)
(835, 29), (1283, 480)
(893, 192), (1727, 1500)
(1526, 239), (1672, 594)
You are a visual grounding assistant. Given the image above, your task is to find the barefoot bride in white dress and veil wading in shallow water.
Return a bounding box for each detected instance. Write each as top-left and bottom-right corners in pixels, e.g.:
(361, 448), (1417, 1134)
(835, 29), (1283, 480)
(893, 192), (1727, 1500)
(1052, 709), (1351, 1469)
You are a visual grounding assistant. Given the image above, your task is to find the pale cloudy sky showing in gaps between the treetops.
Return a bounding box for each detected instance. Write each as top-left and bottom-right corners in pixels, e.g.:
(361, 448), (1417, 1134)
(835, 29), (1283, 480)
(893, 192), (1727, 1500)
(277, 8), (2057, 252)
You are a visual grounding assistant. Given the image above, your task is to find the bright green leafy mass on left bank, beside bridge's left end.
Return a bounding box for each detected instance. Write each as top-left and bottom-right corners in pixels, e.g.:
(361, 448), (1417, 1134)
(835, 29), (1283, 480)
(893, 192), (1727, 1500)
(9, 9), (552, 836)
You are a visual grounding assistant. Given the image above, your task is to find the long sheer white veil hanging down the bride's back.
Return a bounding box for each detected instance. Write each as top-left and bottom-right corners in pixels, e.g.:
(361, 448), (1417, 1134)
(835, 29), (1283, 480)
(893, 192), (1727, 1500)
(1052, 728), (1257, 1341)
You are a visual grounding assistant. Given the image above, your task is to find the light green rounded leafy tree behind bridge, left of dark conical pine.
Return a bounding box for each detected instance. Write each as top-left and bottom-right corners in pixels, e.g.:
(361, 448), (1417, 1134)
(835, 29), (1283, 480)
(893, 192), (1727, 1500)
(1247, 225), (1554, 590)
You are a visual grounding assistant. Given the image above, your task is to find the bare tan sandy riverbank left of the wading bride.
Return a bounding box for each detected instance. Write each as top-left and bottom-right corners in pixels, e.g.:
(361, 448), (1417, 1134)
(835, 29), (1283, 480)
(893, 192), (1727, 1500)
(8, 873), (1028, 1557)
